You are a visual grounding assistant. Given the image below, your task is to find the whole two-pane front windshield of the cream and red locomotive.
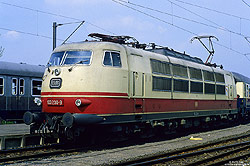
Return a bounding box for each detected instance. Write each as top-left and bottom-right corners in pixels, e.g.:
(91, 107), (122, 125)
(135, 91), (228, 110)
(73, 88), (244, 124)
(48, 50), (92, 66)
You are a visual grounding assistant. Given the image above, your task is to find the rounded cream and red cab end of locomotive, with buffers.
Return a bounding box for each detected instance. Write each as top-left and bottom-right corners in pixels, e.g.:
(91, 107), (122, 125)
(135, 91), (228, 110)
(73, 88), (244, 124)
(26, 42), (129, 137)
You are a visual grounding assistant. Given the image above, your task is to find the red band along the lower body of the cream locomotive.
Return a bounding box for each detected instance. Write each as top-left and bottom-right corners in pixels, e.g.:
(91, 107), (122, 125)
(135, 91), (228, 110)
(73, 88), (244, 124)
(42, 92), (237, 114)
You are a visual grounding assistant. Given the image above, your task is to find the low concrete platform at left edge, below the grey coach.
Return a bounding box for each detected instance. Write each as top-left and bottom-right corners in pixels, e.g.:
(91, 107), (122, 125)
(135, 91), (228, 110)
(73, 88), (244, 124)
(0, 124), (30, 136)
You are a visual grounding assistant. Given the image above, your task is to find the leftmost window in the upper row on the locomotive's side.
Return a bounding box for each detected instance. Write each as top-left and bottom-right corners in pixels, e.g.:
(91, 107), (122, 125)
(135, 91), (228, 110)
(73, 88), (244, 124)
(150, 59), (170, 75)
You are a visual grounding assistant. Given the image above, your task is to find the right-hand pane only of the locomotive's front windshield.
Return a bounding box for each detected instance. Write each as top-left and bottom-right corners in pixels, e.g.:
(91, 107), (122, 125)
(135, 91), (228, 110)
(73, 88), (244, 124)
(64, 50), (92, 65)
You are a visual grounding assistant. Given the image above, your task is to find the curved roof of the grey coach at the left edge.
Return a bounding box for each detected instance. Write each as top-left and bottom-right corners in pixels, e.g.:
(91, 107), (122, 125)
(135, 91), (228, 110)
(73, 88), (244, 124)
(0, 61), (45, 77)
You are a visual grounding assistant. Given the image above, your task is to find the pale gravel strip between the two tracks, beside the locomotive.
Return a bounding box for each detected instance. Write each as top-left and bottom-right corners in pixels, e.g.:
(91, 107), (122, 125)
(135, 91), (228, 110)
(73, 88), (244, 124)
(9, 124), (250, 166)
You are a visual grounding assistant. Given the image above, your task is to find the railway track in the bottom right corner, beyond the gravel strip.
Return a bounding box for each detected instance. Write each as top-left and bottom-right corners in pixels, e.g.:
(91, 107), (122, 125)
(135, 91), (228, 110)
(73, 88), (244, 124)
(115, 135), (250, 166)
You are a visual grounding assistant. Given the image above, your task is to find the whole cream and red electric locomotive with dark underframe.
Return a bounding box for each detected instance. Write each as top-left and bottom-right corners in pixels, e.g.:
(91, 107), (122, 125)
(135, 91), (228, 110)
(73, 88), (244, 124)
(24, 34), (238, 138)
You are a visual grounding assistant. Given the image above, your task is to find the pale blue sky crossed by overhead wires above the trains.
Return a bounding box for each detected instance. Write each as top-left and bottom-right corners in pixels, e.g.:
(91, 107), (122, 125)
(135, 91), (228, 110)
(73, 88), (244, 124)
(0, 0), (250, 77)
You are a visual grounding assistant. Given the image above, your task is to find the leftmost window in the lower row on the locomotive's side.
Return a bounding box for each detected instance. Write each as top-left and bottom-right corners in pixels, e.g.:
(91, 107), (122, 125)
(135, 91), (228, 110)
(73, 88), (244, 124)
(153, 76), (172, 91)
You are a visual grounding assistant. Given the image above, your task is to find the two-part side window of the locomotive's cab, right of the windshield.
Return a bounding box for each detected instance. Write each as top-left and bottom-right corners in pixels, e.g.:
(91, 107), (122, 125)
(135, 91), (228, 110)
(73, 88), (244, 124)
(103, 51), (122, 67)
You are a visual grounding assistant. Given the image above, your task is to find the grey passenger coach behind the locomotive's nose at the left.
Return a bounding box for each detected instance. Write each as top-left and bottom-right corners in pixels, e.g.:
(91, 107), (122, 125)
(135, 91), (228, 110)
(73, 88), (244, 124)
(0, 61), (45, 124)
